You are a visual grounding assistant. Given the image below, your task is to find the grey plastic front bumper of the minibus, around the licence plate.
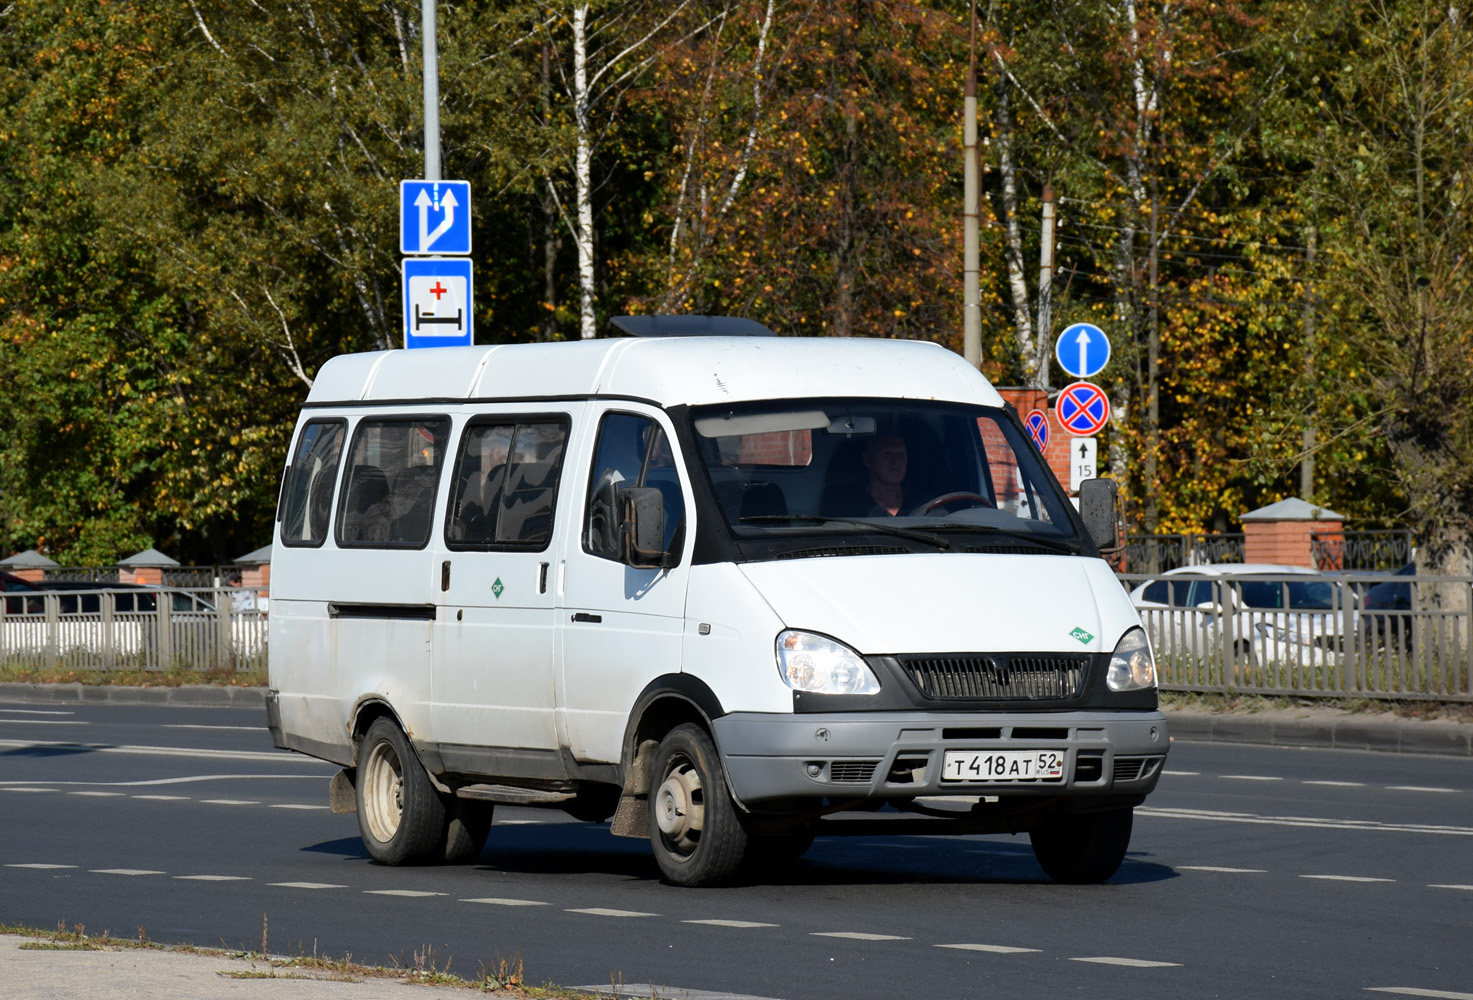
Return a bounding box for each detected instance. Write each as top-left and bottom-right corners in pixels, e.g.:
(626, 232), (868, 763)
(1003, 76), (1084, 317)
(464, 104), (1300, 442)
(713, 711), (1170, 810)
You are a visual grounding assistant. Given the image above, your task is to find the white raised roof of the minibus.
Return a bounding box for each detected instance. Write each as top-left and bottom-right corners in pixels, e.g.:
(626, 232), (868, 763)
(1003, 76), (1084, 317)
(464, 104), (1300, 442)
(306, 336), (1003, 406)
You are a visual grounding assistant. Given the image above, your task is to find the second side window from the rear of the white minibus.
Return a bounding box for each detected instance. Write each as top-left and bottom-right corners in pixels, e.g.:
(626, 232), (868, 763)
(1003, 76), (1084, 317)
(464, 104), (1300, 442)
(337, 417), (451, 548)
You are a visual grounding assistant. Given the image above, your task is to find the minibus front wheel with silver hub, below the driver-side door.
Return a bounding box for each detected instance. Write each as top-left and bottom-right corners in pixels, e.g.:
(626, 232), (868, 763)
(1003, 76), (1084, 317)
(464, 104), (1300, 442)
(650, 723), (748, 887)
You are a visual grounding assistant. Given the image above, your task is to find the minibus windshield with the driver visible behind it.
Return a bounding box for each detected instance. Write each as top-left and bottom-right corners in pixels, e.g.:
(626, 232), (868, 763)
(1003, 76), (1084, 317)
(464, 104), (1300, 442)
(691, 399), (1080, 552)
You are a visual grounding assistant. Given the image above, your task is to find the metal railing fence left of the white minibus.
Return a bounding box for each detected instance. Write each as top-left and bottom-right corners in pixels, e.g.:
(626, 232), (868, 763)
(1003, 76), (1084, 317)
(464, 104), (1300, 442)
(0, 588), (267, 670)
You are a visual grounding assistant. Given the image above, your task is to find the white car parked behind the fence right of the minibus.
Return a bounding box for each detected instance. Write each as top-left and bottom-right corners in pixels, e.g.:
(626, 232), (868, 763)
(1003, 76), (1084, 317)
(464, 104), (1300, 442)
(1130, 563), (1358, 666)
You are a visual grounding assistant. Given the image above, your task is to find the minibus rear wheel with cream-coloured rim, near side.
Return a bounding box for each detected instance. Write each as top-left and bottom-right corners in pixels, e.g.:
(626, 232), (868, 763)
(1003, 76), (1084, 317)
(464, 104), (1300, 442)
(354, 719), (448, 865)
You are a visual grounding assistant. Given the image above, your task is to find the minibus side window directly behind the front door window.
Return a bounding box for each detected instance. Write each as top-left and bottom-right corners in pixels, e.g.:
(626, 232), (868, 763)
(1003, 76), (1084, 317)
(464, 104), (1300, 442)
(445, 417), (570, 551)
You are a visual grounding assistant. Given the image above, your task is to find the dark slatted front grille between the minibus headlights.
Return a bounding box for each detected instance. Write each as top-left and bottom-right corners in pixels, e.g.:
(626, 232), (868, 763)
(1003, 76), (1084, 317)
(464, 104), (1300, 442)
(900, 654), (1090, 701)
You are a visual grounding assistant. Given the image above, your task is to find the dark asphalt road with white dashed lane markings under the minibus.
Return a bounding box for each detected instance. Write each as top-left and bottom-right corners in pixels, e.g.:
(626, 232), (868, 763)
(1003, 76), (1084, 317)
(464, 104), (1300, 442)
(0, 704), (1473, 1000)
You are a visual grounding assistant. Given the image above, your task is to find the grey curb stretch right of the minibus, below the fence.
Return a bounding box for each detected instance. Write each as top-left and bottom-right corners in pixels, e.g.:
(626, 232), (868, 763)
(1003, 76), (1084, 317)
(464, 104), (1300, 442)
(1165, 710), (1473, 757)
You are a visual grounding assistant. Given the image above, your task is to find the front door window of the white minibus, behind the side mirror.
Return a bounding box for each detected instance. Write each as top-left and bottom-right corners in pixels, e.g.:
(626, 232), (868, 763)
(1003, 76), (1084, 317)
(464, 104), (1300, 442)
(583, 414), (685, 560)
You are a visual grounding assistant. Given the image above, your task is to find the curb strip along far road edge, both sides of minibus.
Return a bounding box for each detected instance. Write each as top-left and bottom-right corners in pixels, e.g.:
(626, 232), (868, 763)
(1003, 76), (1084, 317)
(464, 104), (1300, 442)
(0, 683), (1473, 757)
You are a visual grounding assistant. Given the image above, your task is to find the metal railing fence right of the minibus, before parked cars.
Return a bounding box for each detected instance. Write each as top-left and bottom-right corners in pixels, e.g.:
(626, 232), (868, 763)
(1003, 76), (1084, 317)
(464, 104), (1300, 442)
(1121, 573), (1473, 701)
